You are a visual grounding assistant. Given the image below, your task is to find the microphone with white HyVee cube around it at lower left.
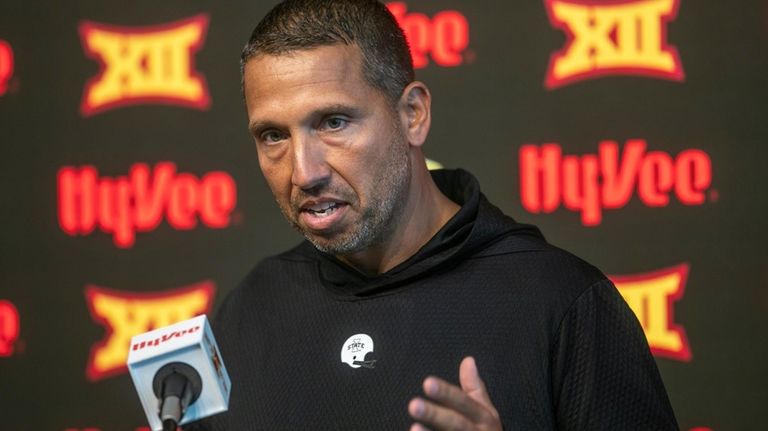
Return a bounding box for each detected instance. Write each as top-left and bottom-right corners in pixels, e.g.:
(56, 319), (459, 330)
(127, 315), (232, 431)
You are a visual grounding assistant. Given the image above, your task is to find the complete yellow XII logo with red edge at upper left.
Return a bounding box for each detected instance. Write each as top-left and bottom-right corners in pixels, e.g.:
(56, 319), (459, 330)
(80, 14), (210, 116)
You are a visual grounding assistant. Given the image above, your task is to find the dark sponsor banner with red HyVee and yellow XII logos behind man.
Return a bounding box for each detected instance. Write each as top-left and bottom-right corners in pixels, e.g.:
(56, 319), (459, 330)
(0, 0), (768, 431)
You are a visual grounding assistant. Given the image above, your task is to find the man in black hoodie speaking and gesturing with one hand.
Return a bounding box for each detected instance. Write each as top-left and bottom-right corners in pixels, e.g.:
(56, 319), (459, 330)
(190, 0), (677, 430)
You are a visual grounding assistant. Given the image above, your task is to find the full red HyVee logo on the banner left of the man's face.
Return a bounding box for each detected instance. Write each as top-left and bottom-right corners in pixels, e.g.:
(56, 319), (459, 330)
(58, 162), (237, 248)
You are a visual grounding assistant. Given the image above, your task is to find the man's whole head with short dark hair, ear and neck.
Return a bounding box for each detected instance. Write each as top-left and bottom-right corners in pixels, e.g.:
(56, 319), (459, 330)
(242, 0), (436, 272)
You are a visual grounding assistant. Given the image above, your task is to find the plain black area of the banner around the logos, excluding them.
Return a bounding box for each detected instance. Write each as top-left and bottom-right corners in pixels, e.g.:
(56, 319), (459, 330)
(0, 0), (768, 431)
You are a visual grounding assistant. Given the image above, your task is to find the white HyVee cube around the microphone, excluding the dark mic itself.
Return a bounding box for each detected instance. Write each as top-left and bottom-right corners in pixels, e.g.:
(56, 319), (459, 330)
(127, 315), (232, 431)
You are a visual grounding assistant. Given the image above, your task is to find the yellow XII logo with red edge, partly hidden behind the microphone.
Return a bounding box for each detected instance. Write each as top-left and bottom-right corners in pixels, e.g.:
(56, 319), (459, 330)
(85, 281), (216, 380)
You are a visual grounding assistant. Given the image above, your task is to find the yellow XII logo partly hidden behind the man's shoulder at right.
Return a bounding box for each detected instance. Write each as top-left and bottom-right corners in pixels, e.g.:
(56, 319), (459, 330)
(610, 264), (691, 362)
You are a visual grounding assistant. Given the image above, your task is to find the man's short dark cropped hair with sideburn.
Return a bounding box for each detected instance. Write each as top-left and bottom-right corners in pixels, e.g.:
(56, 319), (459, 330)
(240, 0), (414, 103)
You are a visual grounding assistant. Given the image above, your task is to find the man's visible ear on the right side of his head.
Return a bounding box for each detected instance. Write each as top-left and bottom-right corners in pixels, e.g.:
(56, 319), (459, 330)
(399, 81), (432, 147)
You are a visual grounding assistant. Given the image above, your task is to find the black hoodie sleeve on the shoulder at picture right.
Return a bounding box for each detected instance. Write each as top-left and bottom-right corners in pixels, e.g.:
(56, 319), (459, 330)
(550, 280), (679, 431)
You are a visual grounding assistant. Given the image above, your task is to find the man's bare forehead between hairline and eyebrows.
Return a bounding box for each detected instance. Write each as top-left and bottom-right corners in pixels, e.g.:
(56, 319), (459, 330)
(243, 44), (384, 121)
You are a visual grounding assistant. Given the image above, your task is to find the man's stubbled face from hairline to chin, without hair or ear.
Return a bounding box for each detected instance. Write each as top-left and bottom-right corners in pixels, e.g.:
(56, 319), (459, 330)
(243, 45), (411, 255)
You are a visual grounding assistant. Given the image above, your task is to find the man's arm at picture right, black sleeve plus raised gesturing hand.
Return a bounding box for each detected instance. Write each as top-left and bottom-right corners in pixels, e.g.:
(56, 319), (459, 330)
(408, 280), (679, 431)
